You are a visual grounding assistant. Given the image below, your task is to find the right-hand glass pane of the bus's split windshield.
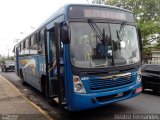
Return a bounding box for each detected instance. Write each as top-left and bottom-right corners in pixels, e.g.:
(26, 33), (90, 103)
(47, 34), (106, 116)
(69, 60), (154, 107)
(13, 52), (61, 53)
(110, 24), (140, 65)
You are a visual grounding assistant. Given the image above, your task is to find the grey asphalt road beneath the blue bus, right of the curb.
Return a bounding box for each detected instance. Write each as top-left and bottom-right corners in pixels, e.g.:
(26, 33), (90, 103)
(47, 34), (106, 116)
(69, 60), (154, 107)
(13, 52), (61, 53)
(0, 72), (160, 120)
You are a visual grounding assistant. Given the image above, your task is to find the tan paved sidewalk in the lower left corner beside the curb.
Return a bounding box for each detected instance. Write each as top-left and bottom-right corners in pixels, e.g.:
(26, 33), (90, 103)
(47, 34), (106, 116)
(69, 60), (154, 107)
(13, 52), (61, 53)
(0, 76), (47, 120)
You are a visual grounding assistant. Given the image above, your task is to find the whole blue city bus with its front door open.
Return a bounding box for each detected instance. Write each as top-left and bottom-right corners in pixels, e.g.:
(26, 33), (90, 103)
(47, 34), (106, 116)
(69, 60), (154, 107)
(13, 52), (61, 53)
(15, 4), (142, 111)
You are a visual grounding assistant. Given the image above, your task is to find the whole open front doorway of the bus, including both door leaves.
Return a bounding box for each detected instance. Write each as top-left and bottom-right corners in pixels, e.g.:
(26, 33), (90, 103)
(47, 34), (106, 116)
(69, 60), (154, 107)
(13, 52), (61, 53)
(46, 24), (65, 105)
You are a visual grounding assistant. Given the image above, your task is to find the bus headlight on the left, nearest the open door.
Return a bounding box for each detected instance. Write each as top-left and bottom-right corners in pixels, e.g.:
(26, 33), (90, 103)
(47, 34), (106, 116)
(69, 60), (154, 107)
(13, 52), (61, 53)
(73, 76), (86, 93)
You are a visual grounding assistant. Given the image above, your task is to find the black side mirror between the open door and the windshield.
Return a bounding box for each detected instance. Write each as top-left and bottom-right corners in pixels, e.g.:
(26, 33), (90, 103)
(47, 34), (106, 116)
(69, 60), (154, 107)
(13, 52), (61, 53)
(60, 25), (70, 44)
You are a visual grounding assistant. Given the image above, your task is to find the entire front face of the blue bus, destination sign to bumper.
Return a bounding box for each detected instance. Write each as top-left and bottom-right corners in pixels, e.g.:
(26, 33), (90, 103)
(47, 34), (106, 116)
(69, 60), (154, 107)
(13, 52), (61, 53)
(63, 5), (142, 111)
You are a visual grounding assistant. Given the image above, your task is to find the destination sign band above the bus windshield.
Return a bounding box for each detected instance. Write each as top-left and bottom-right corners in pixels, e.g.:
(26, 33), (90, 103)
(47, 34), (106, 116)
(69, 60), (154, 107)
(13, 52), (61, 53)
(68, 6), (134, 22)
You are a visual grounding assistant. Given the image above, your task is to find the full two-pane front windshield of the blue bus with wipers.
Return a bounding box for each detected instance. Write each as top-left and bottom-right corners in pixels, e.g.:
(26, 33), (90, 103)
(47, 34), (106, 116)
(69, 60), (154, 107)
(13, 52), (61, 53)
(70, 22), (140, 68)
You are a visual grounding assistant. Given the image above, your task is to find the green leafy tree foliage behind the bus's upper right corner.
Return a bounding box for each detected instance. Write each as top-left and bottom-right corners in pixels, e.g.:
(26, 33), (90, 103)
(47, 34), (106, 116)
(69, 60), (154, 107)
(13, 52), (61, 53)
(106, 0), (160, 53)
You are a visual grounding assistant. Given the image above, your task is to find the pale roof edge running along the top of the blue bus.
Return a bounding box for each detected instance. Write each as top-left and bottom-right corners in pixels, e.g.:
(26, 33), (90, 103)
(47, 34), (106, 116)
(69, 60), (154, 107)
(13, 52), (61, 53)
(15, 4), (132, 47)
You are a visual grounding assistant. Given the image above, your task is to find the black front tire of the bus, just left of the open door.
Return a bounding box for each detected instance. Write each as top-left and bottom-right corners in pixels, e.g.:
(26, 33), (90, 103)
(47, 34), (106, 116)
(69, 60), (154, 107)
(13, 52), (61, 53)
(41, 75), (49, 97)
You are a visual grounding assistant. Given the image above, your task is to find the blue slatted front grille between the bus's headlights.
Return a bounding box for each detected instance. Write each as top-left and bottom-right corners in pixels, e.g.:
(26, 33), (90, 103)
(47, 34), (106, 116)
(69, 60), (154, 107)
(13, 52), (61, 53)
(90, 76), (134, 90)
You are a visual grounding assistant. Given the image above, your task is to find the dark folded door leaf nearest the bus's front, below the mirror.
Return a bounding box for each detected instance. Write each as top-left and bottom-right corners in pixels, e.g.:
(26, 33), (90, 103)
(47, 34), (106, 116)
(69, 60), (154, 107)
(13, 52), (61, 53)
(54, 23), (66, 106)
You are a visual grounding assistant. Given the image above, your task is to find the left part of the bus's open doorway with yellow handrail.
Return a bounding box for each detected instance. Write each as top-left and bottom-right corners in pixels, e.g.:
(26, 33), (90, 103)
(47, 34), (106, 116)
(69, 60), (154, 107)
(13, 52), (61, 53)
(45, 29), (58, 97)
